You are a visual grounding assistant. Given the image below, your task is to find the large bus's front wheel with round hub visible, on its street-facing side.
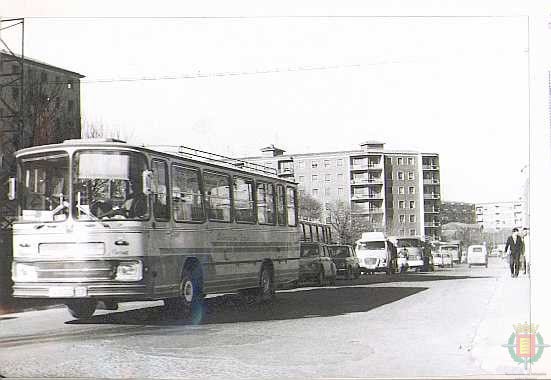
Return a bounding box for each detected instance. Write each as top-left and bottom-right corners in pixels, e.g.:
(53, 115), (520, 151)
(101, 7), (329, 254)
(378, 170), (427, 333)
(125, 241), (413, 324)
(164, 266), (203, 314)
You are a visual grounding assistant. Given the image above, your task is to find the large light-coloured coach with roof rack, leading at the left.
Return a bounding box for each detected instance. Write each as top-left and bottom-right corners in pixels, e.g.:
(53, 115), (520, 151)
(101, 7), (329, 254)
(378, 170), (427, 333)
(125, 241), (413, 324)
(9, 139), (300, 318)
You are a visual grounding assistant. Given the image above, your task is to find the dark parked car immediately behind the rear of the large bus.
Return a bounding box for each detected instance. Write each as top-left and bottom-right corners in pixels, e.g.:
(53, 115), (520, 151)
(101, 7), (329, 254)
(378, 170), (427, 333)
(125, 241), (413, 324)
(299, 242), (337, 286)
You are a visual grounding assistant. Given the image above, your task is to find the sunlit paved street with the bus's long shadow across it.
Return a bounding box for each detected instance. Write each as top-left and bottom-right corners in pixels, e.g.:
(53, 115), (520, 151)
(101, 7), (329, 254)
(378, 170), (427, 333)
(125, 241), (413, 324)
(0, 258), (529, 378)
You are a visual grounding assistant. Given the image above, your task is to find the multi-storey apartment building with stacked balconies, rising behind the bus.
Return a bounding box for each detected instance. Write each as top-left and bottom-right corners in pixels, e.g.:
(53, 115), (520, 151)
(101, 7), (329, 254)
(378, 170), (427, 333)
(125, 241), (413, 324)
(244, 141), (441, 239)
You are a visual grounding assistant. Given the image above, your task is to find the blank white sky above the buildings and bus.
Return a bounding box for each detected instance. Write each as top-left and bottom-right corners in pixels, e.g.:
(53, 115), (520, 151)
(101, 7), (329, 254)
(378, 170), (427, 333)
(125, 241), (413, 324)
(3, 1), (529, 202)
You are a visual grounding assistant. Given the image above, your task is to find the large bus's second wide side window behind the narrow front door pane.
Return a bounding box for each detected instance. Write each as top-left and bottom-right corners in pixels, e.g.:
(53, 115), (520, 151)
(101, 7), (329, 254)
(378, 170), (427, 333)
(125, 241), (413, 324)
(203, 172), (231, 222)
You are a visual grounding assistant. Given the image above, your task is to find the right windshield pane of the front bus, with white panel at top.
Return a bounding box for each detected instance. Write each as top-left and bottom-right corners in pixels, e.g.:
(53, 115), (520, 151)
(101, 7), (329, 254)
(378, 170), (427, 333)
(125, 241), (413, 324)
(73, 150), (149, 220)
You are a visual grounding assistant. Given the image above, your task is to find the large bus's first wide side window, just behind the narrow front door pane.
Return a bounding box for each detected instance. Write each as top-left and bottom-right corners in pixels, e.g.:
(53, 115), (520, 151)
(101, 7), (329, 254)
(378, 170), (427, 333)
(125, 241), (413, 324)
(172, 166), (205, 222)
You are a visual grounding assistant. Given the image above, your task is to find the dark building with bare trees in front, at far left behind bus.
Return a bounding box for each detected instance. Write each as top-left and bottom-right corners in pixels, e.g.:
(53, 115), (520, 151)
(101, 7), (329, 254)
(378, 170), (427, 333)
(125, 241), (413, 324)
(0, 51), (84, 182)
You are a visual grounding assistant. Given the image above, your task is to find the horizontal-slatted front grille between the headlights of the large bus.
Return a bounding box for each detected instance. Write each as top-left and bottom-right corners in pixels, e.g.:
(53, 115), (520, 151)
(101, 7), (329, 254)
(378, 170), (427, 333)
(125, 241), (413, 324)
(35, 260), (117, 282)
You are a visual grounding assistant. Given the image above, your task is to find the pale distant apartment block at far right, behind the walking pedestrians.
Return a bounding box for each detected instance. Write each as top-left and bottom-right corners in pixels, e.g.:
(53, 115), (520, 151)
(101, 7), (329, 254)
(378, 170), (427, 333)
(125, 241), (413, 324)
(475, 200), (527, 232)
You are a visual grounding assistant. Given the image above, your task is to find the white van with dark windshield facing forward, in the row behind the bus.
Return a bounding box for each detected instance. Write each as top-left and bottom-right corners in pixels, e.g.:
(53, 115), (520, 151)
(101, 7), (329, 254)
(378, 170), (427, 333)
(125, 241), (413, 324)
(356, 232), (394, 274)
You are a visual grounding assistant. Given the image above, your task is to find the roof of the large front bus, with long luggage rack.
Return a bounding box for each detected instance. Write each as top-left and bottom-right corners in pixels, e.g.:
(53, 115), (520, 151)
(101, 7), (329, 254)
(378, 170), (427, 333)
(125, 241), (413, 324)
(15, 138), (296, 183)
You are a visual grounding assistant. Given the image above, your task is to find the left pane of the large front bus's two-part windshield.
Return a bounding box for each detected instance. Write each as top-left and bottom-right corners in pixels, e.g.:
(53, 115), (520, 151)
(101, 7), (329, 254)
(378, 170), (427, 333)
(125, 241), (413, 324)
(17, 152), (69, 222)
